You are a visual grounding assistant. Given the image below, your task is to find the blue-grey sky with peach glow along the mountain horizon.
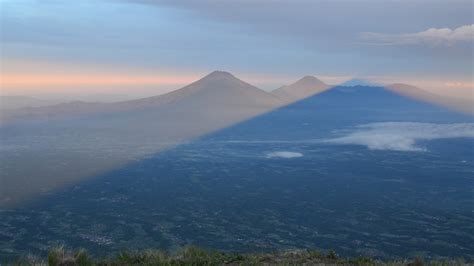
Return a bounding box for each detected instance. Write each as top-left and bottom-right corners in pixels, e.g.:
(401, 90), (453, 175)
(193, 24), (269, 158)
(0, 0), (474, 97)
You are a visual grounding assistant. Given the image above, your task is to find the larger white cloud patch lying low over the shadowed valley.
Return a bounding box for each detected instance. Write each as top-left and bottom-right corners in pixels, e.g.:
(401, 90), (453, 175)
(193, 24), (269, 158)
(323, 122), (474, 151)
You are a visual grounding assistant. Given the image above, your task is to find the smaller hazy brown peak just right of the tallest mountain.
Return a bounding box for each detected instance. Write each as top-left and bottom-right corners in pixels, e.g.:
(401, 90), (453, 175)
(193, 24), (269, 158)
(272, 76), (329, 103)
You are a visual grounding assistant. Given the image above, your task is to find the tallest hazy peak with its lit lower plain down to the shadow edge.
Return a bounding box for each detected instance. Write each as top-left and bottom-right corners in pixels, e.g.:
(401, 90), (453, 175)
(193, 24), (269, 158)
(0, 71), (283, 206)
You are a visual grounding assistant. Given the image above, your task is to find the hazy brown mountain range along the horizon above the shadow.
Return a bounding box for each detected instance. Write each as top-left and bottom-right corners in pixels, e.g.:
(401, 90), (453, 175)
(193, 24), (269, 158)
(0, 71), (474, 124)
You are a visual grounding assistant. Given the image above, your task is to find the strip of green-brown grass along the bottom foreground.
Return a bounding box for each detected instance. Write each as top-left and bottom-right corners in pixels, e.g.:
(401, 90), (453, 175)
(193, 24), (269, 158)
(12, 246), (472, 266)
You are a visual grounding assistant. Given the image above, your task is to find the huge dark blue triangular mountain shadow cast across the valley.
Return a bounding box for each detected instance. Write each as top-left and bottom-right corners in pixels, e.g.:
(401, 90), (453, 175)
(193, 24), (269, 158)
(0, 86), (474, 260)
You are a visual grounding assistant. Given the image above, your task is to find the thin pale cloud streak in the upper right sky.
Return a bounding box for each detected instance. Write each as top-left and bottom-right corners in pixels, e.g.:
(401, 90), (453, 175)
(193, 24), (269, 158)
(361, 24), (474, 46)
